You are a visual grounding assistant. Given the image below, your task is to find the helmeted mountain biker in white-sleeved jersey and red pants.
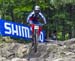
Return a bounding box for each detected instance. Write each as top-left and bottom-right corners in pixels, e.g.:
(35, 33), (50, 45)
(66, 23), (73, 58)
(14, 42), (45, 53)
(27, 5), (46, 35)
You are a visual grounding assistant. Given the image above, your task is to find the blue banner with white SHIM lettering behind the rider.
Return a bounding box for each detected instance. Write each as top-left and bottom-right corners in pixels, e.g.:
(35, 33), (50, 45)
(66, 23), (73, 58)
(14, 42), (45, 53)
(0, 19), (45, 42)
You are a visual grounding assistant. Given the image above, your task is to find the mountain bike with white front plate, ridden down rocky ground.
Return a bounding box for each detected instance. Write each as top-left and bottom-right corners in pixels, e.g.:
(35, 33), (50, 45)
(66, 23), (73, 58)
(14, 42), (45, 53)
(28, 24), (43, 60)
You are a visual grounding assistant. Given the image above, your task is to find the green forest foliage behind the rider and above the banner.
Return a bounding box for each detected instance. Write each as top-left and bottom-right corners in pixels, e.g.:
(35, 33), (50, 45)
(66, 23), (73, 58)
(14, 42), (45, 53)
(0, 0), (75, 40)
